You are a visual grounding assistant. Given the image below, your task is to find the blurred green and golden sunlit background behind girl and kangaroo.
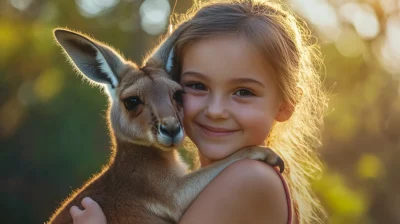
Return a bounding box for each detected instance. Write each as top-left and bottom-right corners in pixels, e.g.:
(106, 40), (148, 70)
(0, 0), (400, 224)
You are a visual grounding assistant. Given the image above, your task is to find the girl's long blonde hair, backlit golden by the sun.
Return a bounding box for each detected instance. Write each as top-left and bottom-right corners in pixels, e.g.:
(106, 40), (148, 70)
(172, 0), (327, 223)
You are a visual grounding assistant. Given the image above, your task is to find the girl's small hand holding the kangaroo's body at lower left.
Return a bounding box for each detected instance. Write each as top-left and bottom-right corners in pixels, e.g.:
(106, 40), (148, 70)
(69, 197), (107, 224)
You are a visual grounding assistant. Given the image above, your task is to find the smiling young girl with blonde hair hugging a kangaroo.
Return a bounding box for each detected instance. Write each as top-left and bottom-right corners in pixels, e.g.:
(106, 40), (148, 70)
(71, 0), (326, 224)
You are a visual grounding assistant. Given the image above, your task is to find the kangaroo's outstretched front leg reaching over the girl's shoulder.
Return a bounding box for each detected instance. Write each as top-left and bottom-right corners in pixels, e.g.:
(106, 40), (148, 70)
(176, 146), (284, 217)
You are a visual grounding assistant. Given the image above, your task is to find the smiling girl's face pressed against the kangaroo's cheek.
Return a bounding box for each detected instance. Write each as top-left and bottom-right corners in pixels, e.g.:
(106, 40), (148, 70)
(181, 36), (288, 166)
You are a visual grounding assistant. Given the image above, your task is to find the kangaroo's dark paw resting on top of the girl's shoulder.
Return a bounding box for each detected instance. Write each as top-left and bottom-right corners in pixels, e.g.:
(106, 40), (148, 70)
(249, 146), (285, 173)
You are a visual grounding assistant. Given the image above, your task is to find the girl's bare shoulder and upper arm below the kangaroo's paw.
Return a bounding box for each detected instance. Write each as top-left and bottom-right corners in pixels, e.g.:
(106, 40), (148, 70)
(180, 160), (290, 224)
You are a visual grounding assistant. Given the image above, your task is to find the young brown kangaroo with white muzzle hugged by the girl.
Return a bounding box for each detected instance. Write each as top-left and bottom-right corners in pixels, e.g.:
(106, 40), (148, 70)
(49, 28), (284, 223)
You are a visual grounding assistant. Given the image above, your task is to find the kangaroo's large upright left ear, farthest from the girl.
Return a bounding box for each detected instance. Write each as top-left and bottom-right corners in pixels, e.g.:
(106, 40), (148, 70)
(54, 29), (126, 89)
